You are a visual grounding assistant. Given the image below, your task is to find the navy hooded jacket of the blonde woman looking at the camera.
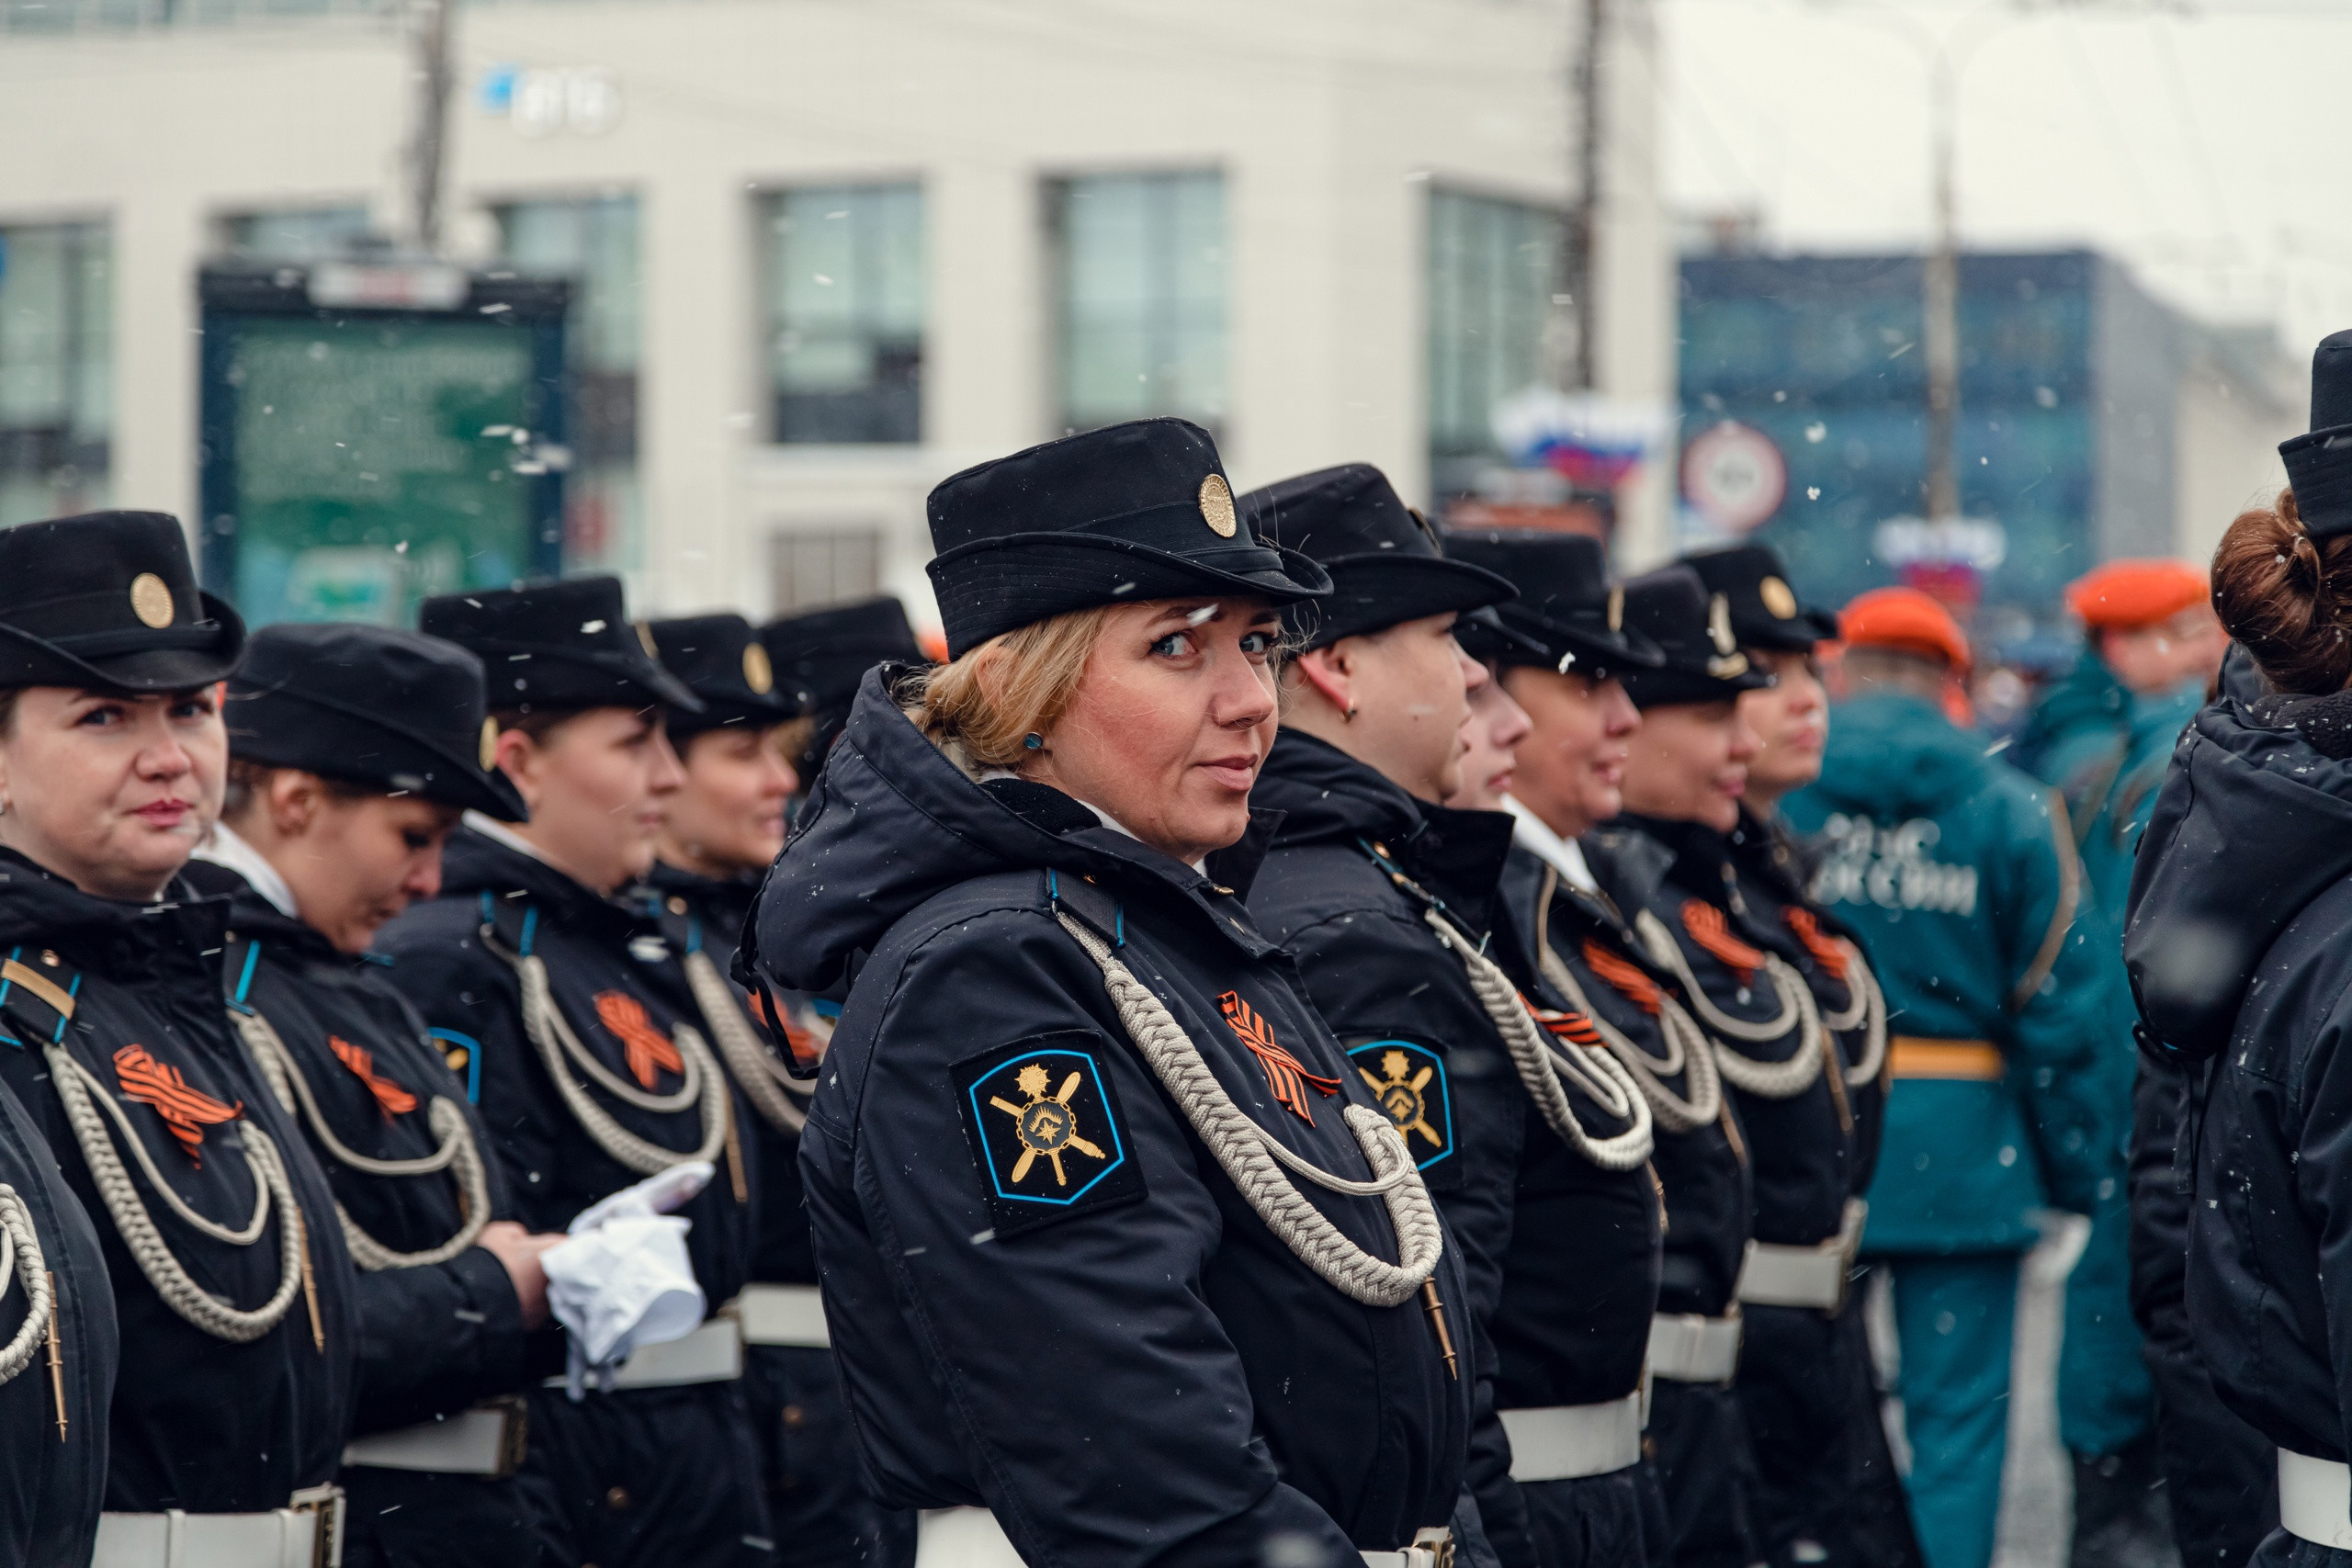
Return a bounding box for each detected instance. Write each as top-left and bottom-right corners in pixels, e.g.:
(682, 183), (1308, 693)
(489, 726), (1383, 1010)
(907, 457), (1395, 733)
(757, 672), (1473, 1568)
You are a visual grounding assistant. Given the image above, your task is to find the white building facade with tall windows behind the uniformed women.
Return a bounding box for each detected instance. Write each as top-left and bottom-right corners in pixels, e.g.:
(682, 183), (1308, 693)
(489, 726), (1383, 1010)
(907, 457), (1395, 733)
(0, 0), (1675, 618)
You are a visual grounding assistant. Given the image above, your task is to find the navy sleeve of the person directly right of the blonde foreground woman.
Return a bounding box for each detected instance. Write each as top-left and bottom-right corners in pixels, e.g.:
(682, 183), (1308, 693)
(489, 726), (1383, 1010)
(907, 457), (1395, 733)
(1284, 912), (1536, 1568)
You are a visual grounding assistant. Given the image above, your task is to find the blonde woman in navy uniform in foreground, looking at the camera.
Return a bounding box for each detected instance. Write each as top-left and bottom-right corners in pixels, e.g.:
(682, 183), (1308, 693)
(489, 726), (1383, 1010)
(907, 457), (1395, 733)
(748, 419), (1477, 1568)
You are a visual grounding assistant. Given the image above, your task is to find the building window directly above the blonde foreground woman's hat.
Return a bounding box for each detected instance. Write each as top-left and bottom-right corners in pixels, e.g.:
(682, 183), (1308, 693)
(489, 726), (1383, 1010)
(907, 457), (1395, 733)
(1049, 172), (1227, 430)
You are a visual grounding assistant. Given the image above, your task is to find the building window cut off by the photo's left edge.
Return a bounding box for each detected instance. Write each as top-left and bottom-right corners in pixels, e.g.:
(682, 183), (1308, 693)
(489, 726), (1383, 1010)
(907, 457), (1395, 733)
(0, 223), (115, 526)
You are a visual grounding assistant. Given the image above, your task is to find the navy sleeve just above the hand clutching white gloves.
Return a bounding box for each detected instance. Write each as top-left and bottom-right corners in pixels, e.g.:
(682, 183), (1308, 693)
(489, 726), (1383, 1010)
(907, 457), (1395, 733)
(379, 909), (571, 1229)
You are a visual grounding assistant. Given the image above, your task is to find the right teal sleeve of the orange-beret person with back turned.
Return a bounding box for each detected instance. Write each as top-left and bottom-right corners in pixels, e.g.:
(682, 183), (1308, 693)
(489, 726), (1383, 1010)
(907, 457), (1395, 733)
(1990, 790), (2131, 1215)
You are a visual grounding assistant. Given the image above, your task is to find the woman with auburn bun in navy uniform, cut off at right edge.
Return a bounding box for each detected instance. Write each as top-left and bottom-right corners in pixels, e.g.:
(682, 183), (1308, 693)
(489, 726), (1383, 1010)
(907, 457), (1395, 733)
(2124, 332), (2352, 1568)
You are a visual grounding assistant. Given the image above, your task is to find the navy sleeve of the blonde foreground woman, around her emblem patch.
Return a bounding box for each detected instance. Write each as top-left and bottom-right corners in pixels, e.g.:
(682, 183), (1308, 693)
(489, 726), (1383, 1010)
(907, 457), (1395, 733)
(837, 912), (1360, 1568)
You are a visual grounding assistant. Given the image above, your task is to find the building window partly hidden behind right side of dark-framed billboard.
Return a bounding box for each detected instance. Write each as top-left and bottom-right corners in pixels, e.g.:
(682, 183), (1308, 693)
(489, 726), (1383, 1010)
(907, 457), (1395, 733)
(496, 195), (644, 573)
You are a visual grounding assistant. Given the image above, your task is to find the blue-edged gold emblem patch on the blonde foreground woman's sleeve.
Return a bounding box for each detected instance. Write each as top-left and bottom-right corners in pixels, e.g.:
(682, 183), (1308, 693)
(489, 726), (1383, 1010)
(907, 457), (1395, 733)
(950, 1030), (1143, 1236)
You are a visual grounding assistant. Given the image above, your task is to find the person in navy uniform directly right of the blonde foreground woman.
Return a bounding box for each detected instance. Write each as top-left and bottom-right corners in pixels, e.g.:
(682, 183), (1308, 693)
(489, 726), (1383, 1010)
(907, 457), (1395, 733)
(1244, 463), (1665, 1568)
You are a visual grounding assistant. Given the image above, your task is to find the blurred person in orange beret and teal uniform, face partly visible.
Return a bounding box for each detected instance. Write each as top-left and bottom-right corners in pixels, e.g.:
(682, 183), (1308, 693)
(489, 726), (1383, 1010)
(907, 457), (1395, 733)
(2018, 559), (2244, 1568)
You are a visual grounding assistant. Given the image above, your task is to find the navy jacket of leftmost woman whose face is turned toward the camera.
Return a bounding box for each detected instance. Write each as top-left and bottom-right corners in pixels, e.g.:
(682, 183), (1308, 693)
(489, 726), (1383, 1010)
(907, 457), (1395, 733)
(0, 851), (360, 1514)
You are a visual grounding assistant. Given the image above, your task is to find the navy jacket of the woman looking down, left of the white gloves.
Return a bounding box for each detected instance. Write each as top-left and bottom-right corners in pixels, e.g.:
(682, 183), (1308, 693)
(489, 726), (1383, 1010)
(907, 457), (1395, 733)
(188, 863), (548, 1432)
